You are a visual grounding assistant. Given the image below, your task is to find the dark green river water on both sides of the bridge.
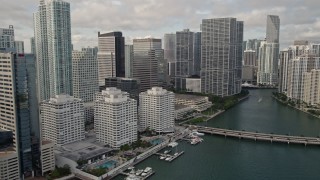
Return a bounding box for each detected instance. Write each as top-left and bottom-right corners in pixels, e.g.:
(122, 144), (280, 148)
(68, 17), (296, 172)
(116, 89), (320, 180)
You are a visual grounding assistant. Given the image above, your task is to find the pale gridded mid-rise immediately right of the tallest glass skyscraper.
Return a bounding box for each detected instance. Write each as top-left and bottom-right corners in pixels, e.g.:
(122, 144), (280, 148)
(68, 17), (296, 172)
(72, 48), (99, 122)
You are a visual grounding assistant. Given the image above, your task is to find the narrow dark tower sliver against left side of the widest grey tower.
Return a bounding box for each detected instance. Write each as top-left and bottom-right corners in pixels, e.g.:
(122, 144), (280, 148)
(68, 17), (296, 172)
(192, 32), (201, 77)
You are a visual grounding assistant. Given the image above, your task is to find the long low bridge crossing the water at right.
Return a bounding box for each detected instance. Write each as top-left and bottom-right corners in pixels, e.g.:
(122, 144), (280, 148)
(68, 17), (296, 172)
(189, 125), (320, 146)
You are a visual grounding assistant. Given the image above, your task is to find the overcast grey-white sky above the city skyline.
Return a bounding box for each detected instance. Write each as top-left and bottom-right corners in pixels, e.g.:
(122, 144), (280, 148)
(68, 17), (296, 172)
(0, 0), (320, 52)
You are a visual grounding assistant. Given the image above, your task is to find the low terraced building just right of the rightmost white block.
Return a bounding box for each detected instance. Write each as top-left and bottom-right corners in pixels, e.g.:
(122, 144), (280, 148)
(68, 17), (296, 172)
(175, 94), (212, 112)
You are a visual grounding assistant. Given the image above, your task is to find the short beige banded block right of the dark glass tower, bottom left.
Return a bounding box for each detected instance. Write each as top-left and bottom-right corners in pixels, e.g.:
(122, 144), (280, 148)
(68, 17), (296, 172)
(40, 140), (56, 176)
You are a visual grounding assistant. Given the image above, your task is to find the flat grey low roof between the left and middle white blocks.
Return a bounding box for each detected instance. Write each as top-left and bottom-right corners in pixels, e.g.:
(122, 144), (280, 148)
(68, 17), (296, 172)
(55, 133), (113, 162)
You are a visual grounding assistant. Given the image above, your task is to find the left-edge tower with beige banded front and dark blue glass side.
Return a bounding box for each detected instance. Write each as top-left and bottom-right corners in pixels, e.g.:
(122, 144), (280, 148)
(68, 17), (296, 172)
(0, 51), (32, 177)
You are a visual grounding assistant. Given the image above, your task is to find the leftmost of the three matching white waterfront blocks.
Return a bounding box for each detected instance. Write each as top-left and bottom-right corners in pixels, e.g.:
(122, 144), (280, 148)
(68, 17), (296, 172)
(40, 95), (85, 146)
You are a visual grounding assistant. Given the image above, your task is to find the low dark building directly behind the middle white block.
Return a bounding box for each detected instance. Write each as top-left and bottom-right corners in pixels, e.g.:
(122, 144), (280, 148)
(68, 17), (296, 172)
(105, 77), (140, 102)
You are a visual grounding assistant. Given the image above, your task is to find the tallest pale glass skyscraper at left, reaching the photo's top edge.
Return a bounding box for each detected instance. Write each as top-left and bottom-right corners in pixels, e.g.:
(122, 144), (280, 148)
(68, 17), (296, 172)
(34, 0), (72, 101)
